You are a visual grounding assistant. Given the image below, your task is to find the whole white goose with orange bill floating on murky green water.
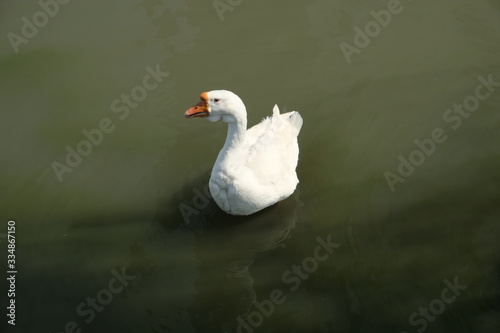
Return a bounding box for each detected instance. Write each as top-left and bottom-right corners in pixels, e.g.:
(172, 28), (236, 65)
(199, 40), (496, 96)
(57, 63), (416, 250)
(185, 90), (302, 215)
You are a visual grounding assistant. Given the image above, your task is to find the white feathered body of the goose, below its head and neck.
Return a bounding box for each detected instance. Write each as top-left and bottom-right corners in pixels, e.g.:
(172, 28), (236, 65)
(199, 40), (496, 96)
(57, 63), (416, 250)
(209, 106), (303, 215)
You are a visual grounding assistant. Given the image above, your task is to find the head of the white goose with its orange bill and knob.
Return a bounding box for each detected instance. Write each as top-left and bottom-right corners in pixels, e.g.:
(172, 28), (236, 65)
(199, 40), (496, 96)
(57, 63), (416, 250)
(184, 90), (246, 123)
